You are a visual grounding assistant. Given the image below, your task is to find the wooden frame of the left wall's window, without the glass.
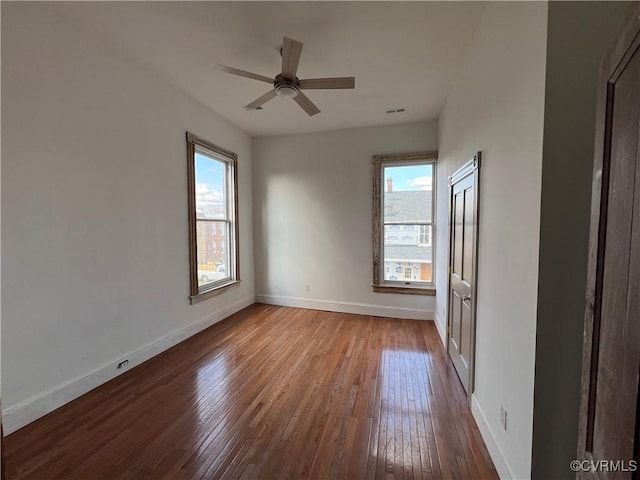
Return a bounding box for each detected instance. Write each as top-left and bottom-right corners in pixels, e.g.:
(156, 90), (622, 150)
(186, 132), (240, 305)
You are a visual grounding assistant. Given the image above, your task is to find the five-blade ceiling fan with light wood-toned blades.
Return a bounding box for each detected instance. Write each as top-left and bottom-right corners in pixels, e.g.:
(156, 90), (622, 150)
(216, 37), (356, 116)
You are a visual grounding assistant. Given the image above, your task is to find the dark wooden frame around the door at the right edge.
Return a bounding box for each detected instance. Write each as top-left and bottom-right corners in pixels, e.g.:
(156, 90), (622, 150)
(577, 2), (640, 468)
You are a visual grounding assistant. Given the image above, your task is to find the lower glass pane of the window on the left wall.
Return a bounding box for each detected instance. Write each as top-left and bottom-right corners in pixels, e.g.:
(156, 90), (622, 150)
(196, 221), (229, 287)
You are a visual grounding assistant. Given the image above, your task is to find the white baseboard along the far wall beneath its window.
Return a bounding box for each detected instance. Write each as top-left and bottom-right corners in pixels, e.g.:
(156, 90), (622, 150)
(256, 294), (433, 320)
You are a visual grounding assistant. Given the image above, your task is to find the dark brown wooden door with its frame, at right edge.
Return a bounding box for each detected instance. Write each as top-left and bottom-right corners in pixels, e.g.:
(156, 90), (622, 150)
(578, 5), (640, 479)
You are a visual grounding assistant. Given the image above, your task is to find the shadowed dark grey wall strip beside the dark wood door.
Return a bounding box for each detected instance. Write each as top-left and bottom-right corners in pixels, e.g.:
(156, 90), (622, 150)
(531, 1), (629, 480)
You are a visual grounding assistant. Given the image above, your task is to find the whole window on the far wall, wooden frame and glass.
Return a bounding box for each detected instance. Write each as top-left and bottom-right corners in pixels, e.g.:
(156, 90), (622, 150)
(373, 152), (438, 295)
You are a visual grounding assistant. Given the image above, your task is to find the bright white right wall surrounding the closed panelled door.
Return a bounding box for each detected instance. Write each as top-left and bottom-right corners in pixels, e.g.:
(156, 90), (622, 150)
(436, 2), (547, 479)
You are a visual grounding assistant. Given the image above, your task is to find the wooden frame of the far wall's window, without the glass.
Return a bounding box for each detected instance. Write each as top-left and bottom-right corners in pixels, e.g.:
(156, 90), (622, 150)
(372, 151), (438, 295)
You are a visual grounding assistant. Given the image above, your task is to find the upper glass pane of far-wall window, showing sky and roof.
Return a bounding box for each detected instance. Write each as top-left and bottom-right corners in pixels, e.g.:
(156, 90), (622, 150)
(383, 165), (433, 223)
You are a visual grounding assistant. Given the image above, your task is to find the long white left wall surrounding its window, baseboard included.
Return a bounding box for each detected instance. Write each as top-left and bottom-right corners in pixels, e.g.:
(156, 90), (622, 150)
(2, 2), (254, 431)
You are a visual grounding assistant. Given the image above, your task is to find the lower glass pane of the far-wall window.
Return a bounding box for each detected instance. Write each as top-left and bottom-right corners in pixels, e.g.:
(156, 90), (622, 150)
(383, 225), (433, 282)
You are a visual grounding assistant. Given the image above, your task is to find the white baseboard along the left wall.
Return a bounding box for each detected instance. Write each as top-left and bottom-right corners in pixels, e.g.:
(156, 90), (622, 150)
(2, 296), (255, 435)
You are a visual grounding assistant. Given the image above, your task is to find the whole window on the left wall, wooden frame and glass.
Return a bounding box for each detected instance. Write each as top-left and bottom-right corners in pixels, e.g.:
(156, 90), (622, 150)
(187, 133), (240, 303)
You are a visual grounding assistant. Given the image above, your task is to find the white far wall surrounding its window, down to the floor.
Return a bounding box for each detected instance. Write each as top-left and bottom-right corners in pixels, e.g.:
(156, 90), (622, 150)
(253, 122), (437, 319)
